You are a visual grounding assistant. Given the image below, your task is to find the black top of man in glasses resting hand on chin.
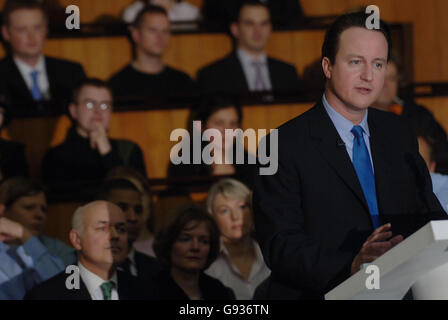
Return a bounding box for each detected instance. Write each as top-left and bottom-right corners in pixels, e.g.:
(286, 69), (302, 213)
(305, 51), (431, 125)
(42, 127), (146, 194)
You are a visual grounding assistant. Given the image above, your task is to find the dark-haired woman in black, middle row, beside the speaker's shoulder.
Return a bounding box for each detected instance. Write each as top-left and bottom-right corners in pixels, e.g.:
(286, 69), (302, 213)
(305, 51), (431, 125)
(168, 97), (256, 185)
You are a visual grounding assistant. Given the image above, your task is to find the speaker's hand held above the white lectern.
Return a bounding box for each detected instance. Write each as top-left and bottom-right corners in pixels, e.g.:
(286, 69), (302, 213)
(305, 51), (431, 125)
(351, 223), (403, 274)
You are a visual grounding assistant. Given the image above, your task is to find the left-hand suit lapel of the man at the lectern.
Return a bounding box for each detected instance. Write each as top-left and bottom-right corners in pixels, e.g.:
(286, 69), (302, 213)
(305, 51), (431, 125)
(310, 102), (369, 213)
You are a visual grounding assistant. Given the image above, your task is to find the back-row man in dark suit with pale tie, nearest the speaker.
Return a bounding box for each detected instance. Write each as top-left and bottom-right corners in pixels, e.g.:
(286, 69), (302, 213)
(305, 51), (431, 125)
(198, 1), (300, 94)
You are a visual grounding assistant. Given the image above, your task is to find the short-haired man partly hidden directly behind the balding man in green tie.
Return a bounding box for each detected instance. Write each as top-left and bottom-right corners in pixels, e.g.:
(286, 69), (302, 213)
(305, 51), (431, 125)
(97, 179), (161, 281)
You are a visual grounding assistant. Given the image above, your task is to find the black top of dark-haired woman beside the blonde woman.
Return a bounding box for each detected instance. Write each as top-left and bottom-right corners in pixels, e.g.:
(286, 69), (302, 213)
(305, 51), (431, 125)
(157, 270), (235, 301)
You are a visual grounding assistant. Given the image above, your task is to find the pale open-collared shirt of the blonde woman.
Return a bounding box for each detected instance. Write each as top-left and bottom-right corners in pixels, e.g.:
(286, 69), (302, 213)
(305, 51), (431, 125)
(205, 240), (271, 300)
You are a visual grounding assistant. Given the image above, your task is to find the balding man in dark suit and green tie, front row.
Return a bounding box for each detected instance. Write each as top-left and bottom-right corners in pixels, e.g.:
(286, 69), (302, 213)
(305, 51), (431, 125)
(25, 201), (157, 300)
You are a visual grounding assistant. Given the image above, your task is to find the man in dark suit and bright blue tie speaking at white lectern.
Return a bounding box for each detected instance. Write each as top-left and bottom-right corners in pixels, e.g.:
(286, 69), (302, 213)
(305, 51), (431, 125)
(253, 13), (445, 299)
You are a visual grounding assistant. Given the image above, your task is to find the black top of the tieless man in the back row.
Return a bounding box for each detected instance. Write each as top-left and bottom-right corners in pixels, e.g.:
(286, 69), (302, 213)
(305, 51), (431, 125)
(109, 64), (196, 98)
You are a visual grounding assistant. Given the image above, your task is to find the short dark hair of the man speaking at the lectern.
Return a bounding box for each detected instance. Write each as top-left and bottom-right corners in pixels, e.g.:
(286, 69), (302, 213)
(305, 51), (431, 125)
(322, 11), (392, 64)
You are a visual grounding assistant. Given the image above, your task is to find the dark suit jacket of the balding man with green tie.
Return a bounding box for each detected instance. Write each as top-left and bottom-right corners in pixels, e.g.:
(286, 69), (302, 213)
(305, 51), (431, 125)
(24, 271), (159, 300)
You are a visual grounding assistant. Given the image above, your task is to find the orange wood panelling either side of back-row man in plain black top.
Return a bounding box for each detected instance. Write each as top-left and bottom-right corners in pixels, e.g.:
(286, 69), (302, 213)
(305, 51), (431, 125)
(41, 34), (232, 80)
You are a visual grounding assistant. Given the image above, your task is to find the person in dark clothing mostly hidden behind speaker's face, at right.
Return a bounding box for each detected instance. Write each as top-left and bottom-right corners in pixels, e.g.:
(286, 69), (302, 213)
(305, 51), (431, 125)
(372, 55), (448, 171)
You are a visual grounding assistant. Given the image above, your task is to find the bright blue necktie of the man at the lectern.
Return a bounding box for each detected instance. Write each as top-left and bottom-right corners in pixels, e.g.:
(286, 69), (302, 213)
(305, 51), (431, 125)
(351, 126), (379, 229)
